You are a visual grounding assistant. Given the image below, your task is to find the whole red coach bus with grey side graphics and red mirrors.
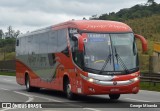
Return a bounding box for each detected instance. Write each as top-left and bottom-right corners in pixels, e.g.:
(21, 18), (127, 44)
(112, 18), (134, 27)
(16, 20), (147, 99)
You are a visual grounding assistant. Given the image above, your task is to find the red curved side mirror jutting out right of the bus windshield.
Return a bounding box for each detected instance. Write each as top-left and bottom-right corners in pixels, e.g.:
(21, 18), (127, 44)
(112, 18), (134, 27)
(134, 34), (148, 53)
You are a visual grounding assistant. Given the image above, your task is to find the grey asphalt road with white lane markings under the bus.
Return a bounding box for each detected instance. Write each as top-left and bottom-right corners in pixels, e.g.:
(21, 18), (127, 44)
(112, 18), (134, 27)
(0, 76), (160, 111)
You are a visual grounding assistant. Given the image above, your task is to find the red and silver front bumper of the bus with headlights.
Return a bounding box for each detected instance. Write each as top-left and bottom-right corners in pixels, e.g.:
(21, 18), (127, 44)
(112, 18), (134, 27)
(82, 76), (140, 95)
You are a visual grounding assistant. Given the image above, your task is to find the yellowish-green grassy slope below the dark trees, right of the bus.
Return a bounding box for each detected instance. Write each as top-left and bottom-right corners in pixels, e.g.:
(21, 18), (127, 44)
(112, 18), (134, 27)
(125, 15), (160, 55)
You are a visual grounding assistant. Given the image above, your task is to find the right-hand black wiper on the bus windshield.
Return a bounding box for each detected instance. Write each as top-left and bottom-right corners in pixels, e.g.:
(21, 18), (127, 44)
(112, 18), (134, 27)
(114, 46), (129, 74)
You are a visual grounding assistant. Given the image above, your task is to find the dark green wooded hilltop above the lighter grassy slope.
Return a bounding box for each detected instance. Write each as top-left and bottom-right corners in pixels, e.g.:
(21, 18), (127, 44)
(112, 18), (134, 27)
(98, 2), (160, 21)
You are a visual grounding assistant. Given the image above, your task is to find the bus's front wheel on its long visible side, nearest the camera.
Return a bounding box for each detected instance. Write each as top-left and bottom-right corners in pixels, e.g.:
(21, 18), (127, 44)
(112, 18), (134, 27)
(65, 79), (74, 100)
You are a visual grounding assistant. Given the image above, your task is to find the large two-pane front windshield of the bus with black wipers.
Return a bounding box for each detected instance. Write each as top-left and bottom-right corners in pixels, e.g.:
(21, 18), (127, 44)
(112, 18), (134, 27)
(84, 33), (138, 74)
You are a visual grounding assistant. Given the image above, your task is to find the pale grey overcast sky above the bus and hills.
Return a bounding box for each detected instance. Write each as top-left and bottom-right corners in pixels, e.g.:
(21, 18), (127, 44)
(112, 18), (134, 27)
(0, 0), (160, 33)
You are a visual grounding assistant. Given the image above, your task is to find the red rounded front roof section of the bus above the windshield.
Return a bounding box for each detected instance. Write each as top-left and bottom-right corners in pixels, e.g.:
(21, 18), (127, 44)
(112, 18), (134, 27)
(53, 20), (132, 32)
